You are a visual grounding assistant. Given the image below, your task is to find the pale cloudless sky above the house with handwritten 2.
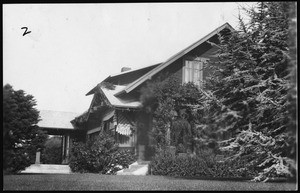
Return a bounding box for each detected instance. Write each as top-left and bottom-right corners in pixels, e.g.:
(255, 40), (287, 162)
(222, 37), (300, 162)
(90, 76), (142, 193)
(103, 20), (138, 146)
(3, 2), (253, 114)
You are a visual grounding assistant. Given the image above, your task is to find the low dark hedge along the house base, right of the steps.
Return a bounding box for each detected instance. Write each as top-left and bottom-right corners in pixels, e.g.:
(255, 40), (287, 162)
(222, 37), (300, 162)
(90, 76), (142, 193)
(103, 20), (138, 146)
(149, 151), (255, 178)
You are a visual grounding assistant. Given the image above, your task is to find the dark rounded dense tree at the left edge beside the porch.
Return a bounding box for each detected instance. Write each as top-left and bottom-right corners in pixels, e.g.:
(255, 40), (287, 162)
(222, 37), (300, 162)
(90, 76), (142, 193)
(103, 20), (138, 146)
(3, 84), (47, 172)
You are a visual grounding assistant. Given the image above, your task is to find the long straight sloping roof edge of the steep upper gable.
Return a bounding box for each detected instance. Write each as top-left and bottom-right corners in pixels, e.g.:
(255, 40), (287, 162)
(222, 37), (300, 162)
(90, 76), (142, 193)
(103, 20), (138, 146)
(115, 23), (234, 96)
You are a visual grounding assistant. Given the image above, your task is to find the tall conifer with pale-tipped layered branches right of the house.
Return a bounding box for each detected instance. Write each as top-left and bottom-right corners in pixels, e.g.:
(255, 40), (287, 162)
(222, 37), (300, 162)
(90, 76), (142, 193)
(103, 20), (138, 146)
(202, 2), (295, 180)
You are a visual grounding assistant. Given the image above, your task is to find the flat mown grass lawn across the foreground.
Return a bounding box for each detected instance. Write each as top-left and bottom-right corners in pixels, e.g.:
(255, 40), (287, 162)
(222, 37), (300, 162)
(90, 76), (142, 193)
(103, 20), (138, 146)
(3, 174), (296, 191)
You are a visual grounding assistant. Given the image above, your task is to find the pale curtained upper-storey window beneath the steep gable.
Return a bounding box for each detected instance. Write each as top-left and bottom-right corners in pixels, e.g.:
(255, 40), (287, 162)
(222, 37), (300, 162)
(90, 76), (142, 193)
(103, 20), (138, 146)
(183, 58), (207, 86)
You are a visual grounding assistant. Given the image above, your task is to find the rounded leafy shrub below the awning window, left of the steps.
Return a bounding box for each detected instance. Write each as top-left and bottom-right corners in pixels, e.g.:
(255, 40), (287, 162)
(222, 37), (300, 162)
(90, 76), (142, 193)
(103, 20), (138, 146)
(69, 133), (136, 174)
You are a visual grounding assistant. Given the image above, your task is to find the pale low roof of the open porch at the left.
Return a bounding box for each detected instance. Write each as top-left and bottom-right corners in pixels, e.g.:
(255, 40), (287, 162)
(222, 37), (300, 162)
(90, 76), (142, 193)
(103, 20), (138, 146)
(37, 110), (78, 130)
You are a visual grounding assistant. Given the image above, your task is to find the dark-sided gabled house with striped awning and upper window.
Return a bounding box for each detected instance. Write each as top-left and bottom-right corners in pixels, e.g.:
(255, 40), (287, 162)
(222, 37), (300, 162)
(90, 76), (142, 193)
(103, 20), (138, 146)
(71, 23), (234, 160)
